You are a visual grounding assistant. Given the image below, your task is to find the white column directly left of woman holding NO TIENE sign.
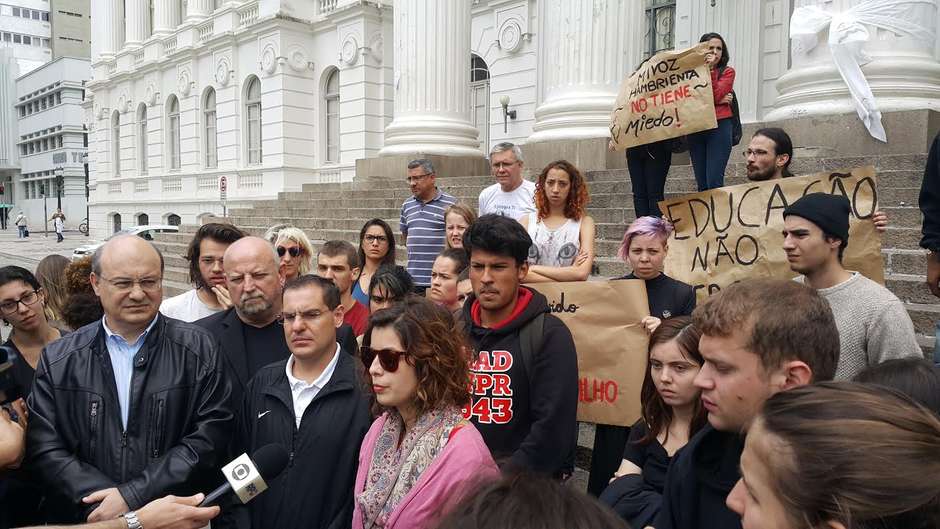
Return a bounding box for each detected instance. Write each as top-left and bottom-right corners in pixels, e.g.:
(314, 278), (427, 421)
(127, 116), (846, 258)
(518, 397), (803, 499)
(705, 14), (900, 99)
(528, 0), (645, 142)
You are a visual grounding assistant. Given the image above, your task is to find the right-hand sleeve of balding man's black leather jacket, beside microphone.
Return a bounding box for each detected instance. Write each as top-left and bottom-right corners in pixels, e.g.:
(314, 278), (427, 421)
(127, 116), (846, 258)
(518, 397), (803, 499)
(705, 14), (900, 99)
(118, 354), (232, 510)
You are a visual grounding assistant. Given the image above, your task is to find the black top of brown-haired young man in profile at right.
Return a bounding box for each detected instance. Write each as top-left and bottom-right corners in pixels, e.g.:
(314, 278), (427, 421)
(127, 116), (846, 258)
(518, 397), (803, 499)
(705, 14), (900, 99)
(653, 425), (744, 529)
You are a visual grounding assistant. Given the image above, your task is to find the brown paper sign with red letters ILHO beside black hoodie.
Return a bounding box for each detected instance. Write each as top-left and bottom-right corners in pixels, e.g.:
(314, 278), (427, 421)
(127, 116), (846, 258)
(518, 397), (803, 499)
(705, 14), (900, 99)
(527, 279), (649, 426)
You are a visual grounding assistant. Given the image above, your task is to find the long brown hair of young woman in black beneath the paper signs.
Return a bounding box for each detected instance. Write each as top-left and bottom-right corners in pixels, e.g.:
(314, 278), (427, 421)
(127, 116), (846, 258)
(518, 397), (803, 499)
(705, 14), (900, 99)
(637, 316), (708, 445)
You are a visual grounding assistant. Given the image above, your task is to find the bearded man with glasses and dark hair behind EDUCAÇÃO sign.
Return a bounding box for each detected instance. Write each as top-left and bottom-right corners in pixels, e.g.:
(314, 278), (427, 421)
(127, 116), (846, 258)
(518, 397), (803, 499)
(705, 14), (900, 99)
(744, 127), (888, 233)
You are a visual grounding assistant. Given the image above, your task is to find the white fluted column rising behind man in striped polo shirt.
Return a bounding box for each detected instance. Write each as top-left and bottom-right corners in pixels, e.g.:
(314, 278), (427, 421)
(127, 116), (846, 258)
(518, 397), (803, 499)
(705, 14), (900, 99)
(376, 0), (481, 157)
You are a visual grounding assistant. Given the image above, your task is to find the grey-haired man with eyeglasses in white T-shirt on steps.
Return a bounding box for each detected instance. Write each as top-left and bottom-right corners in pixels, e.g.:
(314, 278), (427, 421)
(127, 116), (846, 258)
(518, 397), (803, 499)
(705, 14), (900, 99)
(479, 142), (535, 220)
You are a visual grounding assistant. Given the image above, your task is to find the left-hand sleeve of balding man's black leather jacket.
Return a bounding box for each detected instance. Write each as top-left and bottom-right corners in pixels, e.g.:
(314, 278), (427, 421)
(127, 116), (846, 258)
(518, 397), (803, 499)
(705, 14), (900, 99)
(26, 351), (117, 505)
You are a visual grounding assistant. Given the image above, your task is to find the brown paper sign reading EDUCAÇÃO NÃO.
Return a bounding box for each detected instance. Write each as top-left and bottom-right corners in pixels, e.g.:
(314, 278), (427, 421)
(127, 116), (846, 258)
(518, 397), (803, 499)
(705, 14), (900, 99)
(659, 166), (884, 301)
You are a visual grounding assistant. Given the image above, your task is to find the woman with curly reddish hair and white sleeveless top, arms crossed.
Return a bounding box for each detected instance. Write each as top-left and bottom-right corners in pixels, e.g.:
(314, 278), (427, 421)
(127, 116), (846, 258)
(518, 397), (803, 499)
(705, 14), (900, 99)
(519, 160), (596, 283)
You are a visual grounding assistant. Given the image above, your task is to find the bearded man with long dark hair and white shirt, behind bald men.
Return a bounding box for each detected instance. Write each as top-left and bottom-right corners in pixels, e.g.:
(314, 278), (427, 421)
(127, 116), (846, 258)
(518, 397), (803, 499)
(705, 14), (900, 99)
(160, 222), (245, 321)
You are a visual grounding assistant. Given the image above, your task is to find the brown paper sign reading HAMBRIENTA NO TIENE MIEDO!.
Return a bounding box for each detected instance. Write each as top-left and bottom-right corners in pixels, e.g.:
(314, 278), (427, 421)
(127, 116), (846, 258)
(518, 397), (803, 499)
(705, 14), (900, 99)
(610, 42), (718, 149)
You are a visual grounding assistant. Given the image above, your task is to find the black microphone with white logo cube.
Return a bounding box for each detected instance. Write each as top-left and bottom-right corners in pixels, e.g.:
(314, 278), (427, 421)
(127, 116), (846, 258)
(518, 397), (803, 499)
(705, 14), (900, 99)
(199, 443), (288, 507)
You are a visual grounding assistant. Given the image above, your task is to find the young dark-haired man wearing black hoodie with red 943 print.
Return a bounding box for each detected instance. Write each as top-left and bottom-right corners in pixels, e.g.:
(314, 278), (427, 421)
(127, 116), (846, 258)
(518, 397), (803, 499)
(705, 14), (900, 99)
(462, 214), (578, 479)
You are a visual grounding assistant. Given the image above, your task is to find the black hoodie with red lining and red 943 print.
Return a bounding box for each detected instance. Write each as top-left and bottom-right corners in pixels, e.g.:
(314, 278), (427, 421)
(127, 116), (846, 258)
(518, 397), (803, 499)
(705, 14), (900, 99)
(463, 287), (578, 477)
